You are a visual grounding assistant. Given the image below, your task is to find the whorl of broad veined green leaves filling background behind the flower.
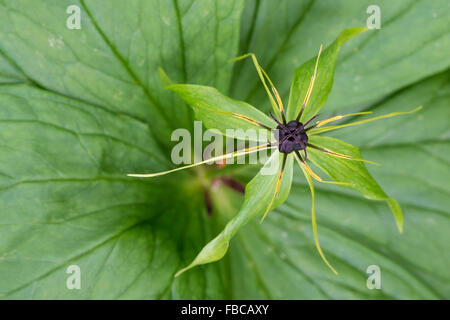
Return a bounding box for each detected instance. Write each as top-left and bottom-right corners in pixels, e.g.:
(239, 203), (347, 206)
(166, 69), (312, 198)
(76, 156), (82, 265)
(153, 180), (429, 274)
(0, 0), (450, 299)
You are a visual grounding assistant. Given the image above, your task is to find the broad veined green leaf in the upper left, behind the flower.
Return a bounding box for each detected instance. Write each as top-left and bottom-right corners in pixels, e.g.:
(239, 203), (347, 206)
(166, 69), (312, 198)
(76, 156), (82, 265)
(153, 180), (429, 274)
(0, 0), (242, 145)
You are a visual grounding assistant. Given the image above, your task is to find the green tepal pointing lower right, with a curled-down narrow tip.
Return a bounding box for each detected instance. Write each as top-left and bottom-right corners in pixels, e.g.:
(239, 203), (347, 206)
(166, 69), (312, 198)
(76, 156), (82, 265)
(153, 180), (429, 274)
(308, 135), (403, 233)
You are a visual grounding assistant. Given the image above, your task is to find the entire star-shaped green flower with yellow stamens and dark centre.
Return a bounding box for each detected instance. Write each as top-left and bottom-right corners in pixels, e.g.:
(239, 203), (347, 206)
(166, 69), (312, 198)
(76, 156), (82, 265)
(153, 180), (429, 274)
(130, 28), (421, 276)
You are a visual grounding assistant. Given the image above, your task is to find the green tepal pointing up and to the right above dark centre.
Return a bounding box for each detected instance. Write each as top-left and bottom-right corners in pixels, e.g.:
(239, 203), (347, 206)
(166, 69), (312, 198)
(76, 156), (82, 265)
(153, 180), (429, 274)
(287, 27), (367, 119)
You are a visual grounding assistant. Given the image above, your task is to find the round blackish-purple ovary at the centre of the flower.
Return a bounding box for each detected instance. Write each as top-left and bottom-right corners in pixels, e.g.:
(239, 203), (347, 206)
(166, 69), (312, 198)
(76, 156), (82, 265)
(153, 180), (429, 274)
(277, 120), (308, 153)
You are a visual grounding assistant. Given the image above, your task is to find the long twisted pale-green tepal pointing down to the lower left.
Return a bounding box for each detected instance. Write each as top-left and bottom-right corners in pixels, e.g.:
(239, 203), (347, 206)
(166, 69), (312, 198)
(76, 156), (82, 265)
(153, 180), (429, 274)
(175, 150), (294, 277)
